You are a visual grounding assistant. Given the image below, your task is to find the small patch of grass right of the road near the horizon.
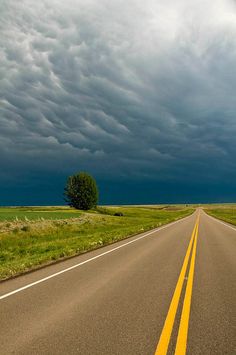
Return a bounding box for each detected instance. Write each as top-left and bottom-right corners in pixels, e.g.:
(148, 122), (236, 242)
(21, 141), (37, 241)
(205, 204), (236, 225)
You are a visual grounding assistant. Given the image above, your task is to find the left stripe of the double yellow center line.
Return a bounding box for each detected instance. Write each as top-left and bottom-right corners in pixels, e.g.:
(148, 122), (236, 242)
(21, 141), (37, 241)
(155, 219), (198, 355)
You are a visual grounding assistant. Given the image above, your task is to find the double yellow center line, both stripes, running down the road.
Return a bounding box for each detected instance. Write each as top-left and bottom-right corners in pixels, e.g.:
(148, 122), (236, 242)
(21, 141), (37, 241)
(155, 215), (199, 355)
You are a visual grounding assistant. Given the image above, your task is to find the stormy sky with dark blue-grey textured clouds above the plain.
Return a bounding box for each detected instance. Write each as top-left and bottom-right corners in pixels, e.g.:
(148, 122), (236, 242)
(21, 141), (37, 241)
(0, 0), (236, 205)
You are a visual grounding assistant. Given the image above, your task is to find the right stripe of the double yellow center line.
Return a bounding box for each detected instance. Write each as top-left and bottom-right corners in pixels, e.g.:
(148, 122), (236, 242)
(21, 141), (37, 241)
(175, 221), (199, 355)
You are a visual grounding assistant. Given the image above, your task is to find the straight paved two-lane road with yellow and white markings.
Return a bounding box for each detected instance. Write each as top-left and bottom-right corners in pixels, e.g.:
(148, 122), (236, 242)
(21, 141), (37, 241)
(0, 209), (236, 355)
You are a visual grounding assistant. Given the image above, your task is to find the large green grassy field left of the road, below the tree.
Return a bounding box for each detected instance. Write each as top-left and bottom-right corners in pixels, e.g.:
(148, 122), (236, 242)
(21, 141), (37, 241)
(0, 206), (193, 279)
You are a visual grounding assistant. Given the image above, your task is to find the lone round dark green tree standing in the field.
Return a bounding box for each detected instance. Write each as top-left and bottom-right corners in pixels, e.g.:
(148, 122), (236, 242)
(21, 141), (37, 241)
(64, 172), (98, 210)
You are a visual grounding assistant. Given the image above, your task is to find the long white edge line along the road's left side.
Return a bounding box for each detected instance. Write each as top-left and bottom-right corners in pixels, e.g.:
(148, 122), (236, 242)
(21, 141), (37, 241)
(0, 214), (192, 300)
